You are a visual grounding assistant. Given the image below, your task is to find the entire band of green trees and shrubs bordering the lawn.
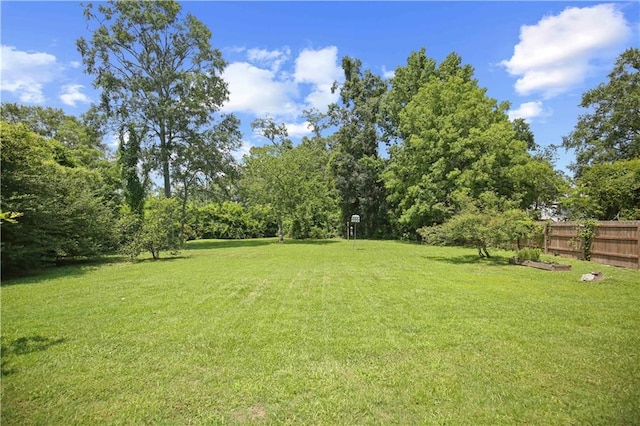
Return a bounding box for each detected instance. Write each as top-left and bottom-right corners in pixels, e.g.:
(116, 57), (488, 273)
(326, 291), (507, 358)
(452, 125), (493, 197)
(0, 1), (640, 273)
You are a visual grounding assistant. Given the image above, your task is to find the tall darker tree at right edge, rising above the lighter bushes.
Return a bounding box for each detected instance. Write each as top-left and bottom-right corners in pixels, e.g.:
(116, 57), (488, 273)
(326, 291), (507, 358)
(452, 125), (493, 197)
(562, 48), (640, 176)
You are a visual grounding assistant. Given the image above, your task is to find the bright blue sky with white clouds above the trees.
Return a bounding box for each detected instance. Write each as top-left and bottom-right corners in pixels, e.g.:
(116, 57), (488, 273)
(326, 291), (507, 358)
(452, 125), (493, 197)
(0, 1), (640, 173)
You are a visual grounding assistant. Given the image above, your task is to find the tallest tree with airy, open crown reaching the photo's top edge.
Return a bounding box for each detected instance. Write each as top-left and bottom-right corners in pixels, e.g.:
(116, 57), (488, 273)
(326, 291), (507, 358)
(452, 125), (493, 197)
(77, 0), (228, 197)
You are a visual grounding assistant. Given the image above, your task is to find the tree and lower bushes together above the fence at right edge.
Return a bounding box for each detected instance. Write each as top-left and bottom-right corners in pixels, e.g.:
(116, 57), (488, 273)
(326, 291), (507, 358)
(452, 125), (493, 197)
(563, 48), (640, 220)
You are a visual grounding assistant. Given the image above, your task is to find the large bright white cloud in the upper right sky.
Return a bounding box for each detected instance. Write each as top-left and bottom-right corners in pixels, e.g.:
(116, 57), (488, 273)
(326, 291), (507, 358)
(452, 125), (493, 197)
(501, 4), (632, 98)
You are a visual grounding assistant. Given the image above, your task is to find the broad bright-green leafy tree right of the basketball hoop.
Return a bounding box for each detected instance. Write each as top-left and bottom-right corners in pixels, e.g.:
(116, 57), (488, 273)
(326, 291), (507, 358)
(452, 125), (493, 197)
(384, 55), (530, 235)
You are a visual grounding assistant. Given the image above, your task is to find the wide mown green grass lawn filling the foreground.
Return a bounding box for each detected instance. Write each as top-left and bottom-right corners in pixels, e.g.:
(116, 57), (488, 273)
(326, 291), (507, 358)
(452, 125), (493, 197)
(1, 240), (640, 425)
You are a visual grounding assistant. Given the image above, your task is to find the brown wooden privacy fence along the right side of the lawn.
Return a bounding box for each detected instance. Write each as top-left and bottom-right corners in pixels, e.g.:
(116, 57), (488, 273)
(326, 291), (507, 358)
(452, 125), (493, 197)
(544, 220), (640, 269)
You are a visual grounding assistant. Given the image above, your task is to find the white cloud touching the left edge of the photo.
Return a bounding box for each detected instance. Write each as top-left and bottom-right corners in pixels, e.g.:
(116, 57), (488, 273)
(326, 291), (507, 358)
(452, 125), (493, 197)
(0, 45), (59, 104)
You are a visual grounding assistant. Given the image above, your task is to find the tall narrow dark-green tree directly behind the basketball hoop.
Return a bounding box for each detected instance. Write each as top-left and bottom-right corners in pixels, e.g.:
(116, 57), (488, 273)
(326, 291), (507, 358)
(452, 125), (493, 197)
(329, 57), (388, 237)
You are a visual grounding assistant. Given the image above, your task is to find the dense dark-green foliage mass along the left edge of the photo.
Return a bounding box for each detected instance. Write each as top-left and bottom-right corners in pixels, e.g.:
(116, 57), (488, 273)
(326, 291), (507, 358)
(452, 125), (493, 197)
(0, 122), (115, 273)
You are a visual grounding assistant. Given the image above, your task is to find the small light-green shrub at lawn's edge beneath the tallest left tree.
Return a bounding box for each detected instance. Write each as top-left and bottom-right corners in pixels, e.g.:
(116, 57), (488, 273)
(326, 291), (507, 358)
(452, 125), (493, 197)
(119, 197), (184, 259)
